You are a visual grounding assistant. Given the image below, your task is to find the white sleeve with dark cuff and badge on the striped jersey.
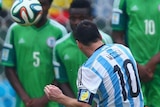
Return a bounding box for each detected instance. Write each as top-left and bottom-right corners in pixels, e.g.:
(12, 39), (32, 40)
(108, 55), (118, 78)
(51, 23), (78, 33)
(77, 67), (102, 105)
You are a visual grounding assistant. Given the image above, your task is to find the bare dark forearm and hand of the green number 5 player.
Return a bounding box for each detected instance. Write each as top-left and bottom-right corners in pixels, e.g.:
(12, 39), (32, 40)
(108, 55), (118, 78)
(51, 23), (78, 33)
(5, 67), (49, 107)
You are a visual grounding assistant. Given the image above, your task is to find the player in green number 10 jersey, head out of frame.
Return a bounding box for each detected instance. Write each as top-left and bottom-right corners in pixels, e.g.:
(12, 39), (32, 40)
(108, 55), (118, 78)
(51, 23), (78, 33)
(112, 0), (160, 107)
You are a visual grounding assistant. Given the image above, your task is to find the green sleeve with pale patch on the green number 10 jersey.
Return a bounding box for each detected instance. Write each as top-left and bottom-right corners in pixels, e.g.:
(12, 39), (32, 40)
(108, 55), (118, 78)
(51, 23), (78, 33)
(111, 0), (128, 30)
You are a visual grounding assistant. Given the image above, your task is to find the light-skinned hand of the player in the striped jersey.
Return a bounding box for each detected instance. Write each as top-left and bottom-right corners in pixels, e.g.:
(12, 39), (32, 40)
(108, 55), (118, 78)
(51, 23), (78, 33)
(44, 85), (63, 101)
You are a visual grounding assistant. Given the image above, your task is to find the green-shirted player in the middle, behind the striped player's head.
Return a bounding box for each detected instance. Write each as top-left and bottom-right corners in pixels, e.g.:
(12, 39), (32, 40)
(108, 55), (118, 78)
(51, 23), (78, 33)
(54, 0), (112, 100)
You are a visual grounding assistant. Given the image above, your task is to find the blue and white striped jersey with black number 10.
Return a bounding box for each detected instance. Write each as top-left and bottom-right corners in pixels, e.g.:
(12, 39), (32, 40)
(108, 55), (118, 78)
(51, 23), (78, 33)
(77, 44), (144, 107)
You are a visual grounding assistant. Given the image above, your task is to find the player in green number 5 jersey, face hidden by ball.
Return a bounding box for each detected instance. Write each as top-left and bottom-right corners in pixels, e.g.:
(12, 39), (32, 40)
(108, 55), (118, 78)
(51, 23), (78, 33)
(2, 0), (67, 107)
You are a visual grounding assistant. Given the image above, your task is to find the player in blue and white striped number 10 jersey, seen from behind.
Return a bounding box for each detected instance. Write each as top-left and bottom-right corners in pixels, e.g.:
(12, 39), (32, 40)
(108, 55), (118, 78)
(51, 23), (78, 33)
(44, 20), (144, 107)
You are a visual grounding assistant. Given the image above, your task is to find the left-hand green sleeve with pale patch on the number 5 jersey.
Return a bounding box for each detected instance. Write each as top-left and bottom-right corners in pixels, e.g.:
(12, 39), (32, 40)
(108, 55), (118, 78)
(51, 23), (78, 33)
(1, 24), (16, 66)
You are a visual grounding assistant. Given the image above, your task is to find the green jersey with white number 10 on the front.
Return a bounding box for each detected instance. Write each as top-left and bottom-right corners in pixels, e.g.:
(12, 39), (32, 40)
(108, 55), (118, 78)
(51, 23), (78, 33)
(112, 0), (160, 64)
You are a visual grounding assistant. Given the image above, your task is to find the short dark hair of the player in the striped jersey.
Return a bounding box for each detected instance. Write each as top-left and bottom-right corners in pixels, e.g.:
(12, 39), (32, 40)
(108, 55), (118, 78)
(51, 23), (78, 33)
(75, 20), (101, 45)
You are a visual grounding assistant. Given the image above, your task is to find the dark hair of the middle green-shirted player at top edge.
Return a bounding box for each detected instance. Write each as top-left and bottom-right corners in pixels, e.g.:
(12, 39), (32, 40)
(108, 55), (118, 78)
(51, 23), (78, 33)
(69, 0), (92, 15)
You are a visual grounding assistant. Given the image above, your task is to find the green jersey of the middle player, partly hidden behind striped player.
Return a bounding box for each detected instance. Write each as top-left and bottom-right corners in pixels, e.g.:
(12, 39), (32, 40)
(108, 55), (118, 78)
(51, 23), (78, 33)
(53, 31), (112, 96)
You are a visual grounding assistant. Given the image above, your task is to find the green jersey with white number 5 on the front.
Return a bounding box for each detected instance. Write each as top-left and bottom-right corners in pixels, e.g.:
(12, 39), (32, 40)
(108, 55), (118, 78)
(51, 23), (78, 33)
(2, 20), (67, 107)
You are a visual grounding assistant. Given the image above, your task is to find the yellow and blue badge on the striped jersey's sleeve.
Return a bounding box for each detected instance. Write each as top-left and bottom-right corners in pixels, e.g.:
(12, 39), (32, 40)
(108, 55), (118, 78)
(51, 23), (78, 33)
(78, 89), (91, 103)
